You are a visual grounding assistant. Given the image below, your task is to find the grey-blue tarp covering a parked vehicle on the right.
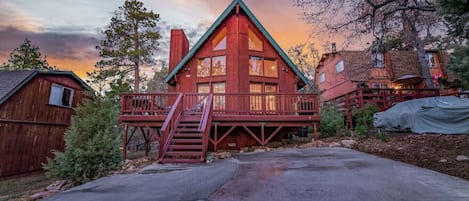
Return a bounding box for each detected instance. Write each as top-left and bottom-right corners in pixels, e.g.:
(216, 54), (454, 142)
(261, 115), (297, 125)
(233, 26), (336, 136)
(373, 96), (469, 134)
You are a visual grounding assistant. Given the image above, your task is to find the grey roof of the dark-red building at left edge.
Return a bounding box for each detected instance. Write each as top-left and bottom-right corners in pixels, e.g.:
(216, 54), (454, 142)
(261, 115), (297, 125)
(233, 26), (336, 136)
(0, 70), (92, 105)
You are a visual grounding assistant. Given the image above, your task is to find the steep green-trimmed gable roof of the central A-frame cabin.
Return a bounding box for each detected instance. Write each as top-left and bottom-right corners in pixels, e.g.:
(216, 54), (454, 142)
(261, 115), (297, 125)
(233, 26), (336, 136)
(165, 0), (308, 83)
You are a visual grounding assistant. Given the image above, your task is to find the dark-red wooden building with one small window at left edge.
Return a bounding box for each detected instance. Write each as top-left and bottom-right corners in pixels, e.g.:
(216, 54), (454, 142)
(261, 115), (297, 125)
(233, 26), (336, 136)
(0, 70), (91, 177)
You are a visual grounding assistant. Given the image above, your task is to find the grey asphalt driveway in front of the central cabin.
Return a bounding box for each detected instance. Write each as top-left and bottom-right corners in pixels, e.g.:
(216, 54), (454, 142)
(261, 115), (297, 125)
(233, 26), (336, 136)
(46, 148), (469, 201)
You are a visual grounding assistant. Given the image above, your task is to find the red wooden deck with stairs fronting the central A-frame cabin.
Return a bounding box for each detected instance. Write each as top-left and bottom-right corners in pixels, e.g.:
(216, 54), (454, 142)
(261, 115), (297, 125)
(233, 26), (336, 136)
(120, 93), (320, 162)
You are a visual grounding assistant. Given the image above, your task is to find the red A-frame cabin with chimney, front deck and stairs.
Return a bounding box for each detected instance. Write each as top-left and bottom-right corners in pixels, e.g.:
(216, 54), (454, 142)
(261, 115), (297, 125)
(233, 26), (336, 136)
(120, 0), (320, 162)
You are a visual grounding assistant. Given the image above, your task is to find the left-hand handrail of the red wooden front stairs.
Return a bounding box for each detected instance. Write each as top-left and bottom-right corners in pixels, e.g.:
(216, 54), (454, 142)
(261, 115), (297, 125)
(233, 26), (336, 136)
(159, 93), (183, 161)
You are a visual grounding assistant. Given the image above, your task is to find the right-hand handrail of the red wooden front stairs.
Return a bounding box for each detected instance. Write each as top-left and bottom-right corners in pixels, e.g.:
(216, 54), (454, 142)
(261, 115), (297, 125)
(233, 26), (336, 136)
(198, 94), (213, 162)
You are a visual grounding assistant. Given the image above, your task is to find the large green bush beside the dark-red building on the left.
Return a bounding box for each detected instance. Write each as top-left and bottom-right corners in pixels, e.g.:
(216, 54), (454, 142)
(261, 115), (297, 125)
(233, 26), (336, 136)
(43, 98), (122, 184)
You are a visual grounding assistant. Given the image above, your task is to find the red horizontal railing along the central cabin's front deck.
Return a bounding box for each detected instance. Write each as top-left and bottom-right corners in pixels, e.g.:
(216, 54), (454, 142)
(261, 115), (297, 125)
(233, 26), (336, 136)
(121, 93), (319, 116)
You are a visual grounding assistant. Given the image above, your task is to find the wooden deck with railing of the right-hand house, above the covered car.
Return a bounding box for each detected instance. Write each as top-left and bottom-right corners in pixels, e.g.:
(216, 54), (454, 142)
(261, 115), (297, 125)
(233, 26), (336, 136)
(325, 88), (469, 129)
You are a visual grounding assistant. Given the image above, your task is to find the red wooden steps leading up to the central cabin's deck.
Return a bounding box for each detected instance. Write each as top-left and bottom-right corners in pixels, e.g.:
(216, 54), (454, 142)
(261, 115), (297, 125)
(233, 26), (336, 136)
(160, 114), (205, 163)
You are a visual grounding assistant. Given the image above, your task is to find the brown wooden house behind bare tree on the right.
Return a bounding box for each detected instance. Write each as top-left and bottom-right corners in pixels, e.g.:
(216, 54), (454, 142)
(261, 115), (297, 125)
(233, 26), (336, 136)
(316, 50), (451, 101)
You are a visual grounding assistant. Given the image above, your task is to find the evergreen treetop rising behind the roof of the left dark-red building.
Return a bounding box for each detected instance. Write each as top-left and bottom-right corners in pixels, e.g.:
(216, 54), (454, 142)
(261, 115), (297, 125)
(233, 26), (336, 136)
(0, 38), (56, 70)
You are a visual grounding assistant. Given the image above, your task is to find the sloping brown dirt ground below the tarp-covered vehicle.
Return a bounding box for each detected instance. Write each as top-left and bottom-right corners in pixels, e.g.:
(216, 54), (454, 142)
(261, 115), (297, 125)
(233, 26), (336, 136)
(353, 133), (469, 180)
